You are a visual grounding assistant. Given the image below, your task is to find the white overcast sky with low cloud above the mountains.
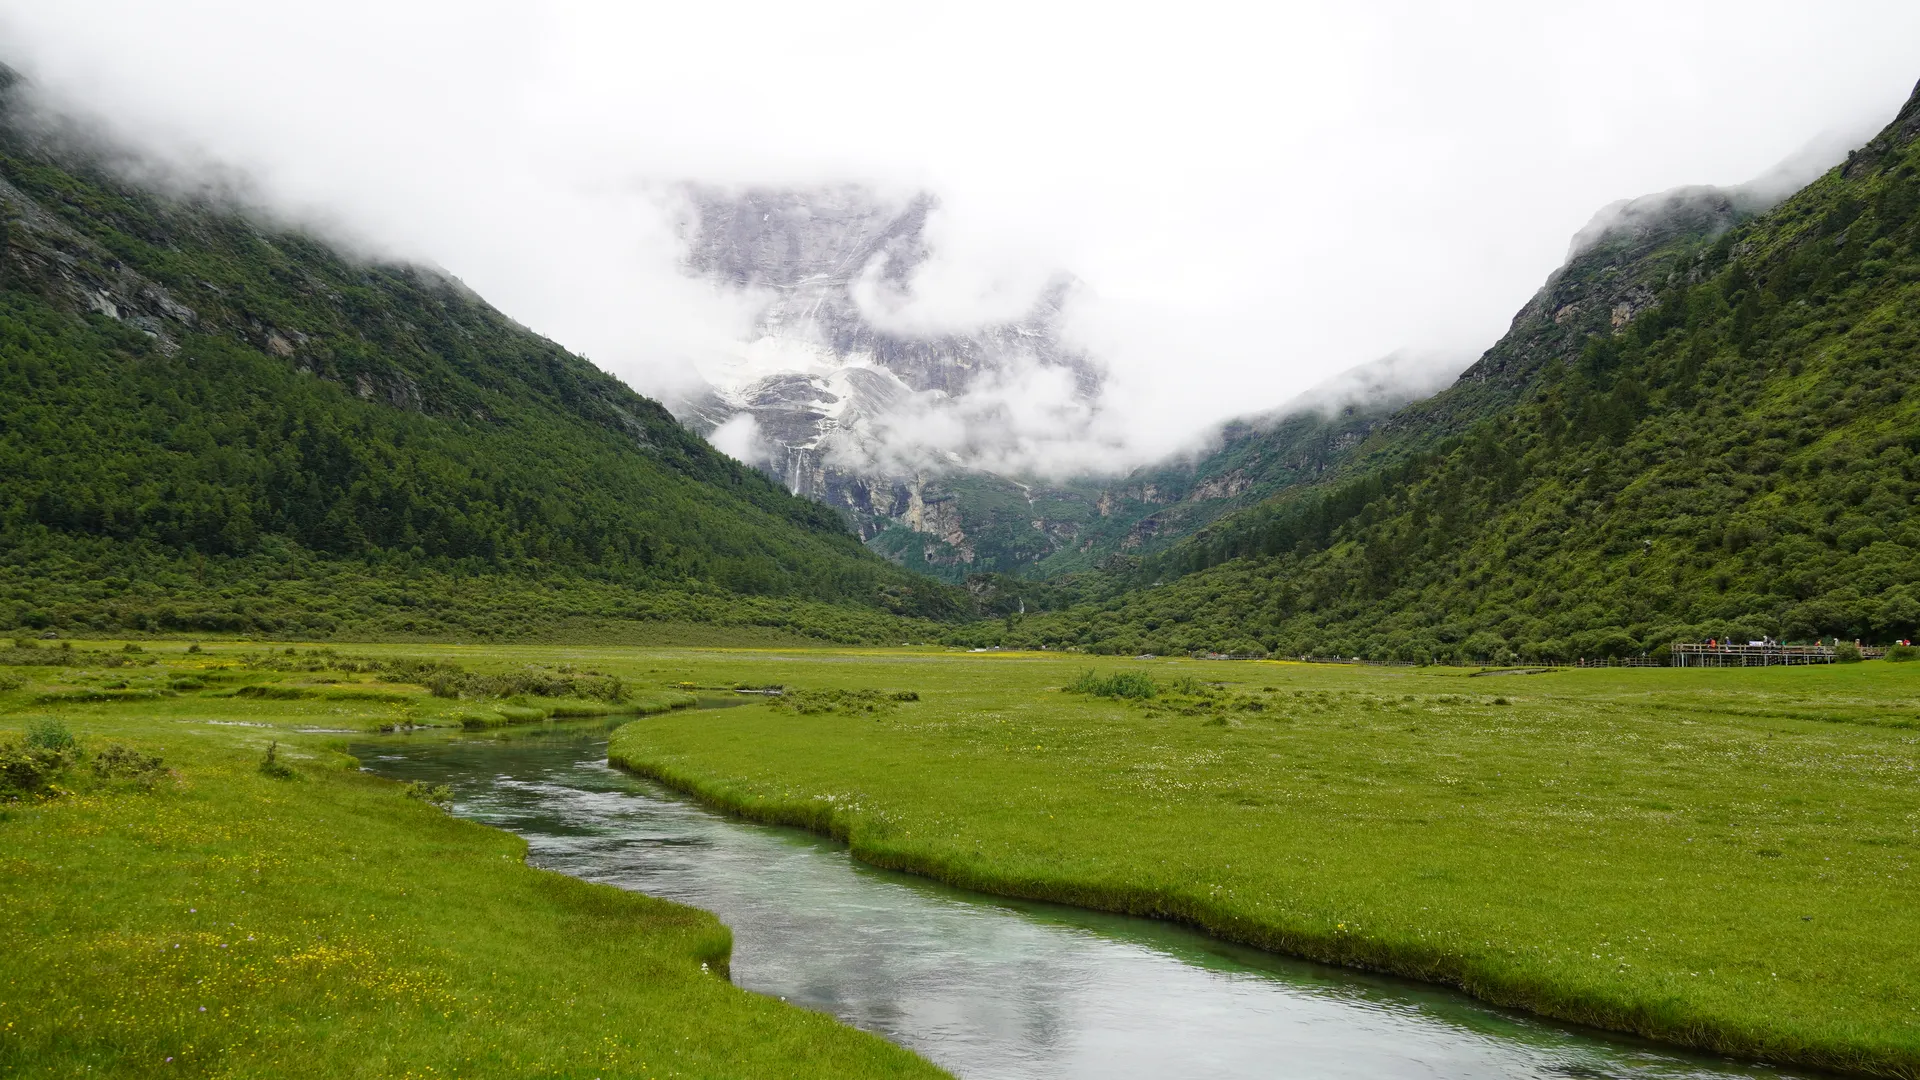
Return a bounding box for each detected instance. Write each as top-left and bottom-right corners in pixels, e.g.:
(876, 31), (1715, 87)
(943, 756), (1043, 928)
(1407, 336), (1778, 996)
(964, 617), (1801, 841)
(0, 0), (1920, 466)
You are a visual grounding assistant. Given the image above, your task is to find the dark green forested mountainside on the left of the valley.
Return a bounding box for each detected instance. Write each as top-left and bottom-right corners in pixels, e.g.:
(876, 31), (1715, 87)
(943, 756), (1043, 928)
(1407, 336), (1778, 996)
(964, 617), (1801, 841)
(0, 83), (964, 640)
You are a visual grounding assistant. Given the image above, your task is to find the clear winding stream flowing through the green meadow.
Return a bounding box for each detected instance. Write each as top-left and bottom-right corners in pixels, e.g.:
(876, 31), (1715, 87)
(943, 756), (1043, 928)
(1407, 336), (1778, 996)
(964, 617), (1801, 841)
(353, 726), (1801, 1080)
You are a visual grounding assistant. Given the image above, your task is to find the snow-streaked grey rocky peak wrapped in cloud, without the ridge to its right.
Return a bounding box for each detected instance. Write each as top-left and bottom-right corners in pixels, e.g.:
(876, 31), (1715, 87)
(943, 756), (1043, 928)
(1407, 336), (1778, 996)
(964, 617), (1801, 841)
(670, 186), (1100, 577)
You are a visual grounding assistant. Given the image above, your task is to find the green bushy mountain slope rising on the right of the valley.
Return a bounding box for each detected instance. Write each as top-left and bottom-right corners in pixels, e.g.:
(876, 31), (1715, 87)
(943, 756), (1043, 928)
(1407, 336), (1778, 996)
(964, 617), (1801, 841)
(973, 77), (1920, 659)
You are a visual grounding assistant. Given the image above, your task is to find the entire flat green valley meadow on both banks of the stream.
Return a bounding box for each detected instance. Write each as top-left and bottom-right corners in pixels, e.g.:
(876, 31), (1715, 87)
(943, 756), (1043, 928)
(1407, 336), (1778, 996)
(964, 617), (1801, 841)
(11, 642), (1920, 1076)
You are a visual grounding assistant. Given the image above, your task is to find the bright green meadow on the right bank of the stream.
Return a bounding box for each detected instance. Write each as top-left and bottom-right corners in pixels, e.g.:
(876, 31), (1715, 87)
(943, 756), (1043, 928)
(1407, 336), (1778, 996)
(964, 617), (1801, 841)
(612, 641), (1920, 1076)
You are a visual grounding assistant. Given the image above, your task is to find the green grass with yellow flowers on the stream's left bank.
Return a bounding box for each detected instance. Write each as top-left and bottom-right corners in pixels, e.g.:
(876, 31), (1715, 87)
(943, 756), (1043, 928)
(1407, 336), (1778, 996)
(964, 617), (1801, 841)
(0, 644), (941, 1078)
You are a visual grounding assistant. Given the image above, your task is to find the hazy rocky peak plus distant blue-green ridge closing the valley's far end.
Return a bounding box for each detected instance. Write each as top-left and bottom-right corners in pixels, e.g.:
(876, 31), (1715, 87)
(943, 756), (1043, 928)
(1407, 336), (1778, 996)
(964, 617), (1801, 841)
(668, 186), (1452, 580)
